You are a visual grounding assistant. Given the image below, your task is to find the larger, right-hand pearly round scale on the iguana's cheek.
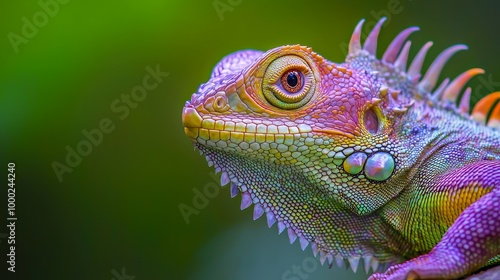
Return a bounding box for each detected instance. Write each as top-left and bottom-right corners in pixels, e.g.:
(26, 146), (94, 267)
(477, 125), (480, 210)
(365, 152), (394, 181)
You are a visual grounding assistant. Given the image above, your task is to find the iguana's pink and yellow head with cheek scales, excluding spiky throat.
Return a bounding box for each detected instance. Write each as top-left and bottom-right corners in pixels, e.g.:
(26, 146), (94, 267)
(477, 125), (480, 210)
(183, 39), (410, 210)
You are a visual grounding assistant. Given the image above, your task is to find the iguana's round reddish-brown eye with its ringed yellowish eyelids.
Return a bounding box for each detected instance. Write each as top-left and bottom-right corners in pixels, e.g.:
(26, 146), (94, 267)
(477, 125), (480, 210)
(262, 55), (316, 110)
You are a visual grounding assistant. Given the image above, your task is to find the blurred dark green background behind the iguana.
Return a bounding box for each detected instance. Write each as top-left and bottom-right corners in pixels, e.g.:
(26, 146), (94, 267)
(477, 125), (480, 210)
(0, 0), (500, 280)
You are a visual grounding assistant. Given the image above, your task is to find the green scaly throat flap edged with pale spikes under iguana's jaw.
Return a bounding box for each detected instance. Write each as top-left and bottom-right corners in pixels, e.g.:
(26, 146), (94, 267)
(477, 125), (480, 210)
(195, 143), (399, 272)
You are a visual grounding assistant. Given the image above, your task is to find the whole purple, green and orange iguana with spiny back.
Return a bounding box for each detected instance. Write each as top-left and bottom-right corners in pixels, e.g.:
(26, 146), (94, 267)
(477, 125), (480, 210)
(182, 19), (500, 279)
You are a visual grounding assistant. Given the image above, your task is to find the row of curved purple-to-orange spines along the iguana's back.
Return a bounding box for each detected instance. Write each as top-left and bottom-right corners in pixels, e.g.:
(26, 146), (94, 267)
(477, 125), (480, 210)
(346, 18), (500, 128)
